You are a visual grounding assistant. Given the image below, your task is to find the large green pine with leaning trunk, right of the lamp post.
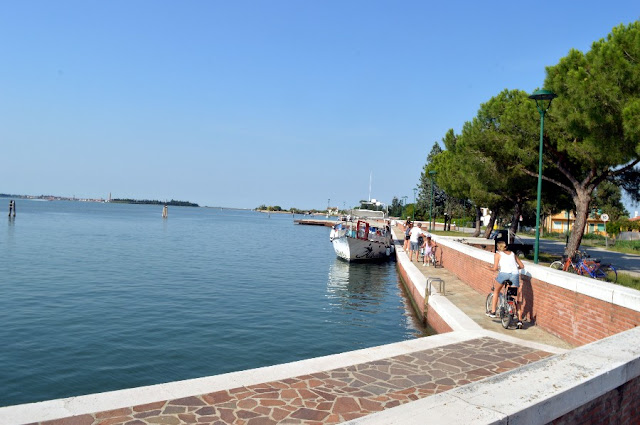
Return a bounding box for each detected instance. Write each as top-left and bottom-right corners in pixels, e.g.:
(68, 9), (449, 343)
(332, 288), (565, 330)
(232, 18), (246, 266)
(529, 22), (640, 253)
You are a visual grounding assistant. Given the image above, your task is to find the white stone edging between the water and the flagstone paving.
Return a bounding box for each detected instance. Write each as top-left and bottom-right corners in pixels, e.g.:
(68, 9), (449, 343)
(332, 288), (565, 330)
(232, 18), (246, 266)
(0, 330), (563, 425)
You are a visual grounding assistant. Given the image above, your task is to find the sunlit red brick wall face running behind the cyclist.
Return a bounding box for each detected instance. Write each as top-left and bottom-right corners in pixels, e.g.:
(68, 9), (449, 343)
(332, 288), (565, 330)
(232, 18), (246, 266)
(439, 245), (640, 346)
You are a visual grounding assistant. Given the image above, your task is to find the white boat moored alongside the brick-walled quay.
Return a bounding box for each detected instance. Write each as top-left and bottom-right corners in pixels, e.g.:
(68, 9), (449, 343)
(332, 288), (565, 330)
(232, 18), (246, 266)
(329, 210), (394, 261)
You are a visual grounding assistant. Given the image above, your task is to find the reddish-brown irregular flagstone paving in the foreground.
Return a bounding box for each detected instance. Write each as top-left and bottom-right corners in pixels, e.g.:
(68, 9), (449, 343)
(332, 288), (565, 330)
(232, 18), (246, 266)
(39, 337), (551, 425)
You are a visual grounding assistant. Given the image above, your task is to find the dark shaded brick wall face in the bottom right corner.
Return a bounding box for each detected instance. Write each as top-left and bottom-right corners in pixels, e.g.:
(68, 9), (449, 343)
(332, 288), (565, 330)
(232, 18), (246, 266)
(550, 378), (640, 425)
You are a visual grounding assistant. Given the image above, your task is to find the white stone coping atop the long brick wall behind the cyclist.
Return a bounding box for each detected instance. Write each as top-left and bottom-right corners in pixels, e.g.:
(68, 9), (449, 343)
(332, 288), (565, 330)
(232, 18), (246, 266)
(437, 236), (640, 311)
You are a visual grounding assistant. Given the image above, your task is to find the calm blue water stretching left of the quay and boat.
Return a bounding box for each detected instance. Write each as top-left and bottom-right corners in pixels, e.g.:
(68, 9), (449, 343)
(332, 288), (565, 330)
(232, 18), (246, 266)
(0, 198), (423, 406)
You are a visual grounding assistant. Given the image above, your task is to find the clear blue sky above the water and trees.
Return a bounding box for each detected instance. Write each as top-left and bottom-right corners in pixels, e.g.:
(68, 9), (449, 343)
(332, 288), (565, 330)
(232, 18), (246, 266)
(0, 0), (640, 209)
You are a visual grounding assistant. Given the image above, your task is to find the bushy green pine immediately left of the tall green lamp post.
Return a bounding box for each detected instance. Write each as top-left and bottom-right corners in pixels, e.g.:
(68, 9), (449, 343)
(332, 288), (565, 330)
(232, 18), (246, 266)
(437, 90), (537, 237)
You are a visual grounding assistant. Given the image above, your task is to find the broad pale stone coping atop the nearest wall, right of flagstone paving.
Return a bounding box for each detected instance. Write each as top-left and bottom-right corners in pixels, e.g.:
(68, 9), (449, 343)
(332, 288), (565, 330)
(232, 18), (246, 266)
(345, 327), (640, 425)
